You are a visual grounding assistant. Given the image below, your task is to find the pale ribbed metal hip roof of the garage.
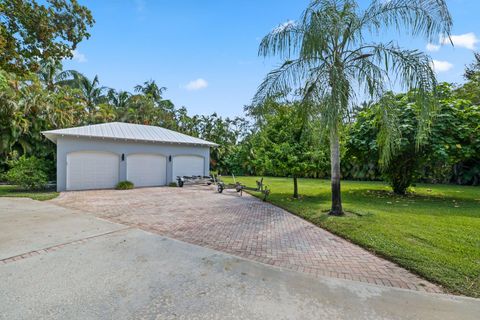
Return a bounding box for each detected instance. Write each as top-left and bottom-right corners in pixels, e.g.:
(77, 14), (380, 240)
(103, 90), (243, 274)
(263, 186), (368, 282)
(42, 122), (218, 147)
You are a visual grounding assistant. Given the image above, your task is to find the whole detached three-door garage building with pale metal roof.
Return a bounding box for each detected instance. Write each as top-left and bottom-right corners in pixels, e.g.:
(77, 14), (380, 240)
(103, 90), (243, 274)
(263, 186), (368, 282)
(42, 122), (217, 191)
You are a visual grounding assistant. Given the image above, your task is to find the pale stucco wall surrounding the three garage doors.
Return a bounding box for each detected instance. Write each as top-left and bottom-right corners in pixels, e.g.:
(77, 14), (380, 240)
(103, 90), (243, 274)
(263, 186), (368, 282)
(57, 136), (210, 191)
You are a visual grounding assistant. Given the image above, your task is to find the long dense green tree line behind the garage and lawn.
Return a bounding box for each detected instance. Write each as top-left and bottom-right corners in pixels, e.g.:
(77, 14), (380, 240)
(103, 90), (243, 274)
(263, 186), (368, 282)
(0, 55), (480, 191)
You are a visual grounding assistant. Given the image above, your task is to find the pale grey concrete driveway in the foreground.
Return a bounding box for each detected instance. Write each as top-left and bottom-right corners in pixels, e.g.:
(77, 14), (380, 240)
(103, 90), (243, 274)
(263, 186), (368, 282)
(0, 198), (480, 320)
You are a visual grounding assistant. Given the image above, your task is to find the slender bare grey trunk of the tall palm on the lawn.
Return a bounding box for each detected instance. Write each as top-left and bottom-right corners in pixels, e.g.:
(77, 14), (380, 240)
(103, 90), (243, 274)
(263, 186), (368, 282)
(329, 132), (343, 216)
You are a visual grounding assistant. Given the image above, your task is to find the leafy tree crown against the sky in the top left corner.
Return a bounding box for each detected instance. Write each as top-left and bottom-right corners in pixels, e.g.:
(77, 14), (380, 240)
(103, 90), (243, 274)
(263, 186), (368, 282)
(0, 0), (94, 74)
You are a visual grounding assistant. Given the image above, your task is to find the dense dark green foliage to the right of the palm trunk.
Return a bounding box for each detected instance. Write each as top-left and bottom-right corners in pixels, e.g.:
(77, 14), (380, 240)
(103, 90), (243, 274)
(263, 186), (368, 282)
(344, 83), (480, 194)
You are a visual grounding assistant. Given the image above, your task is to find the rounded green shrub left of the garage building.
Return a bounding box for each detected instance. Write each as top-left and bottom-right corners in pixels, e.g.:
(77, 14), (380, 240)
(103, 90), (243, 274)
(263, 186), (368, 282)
(4, 156), (48, 190)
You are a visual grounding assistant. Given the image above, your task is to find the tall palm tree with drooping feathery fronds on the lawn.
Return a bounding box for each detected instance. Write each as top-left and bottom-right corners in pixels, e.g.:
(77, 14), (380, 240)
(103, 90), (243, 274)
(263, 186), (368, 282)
(253, 0), (452, 215)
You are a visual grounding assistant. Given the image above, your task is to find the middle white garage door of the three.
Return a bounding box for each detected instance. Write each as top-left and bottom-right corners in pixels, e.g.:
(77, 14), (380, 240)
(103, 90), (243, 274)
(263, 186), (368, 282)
(127, 154), (167, 187)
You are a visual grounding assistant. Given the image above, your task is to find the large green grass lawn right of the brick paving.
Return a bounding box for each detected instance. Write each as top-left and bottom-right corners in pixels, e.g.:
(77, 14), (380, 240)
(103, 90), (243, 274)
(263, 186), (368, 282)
(222, 177), (480, 297)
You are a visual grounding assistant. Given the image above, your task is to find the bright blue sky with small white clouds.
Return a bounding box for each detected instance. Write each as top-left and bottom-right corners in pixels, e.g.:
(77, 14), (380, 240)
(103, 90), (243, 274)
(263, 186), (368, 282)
(64, 0), (480, 116)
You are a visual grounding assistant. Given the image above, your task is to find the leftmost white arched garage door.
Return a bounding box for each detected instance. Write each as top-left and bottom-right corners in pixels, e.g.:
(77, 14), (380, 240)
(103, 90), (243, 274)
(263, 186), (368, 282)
(67, 151), (120, 190)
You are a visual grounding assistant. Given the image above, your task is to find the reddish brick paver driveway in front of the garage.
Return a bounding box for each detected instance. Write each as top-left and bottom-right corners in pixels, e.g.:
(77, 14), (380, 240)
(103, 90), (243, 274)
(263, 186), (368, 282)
(52, 186), (441, 292)
